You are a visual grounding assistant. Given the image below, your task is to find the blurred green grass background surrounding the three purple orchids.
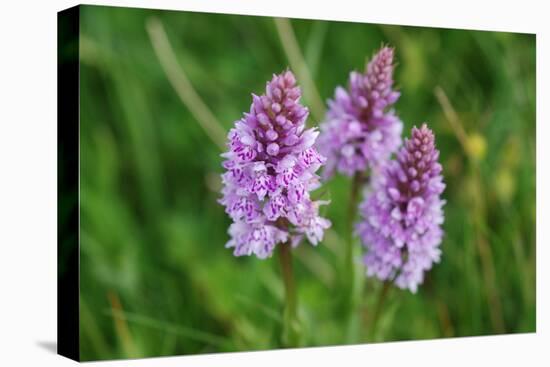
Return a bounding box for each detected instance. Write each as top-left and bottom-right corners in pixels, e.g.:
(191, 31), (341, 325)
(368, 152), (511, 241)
(75, 6), (536, 360)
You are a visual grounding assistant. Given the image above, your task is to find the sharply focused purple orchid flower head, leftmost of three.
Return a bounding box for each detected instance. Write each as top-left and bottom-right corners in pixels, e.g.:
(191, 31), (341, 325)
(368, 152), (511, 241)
(220, 71), (330, 259)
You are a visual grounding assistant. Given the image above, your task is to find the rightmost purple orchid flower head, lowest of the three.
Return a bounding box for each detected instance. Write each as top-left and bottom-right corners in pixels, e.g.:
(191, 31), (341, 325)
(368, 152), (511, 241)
(356, 124), (445, 293)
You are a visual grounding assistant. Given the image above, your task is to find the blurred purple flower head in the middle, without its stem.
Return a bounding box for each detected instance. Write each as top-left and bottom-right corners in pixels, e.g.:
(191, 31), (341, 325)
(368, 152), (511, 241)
(318, 47), (403, 179)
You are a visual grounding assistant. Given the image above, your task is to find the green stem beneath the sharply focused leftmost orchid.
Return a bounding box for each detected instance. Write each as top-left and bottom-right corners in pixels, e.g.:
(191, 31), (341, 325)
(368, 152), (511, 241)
(277, 243), (300, 348)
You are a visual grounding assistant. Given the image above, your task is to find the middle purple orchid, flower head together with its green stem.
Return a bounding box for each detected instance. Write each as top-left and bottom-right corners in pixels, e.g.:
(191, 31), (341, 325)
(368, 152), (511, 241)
(317, 47), (403, 339)
